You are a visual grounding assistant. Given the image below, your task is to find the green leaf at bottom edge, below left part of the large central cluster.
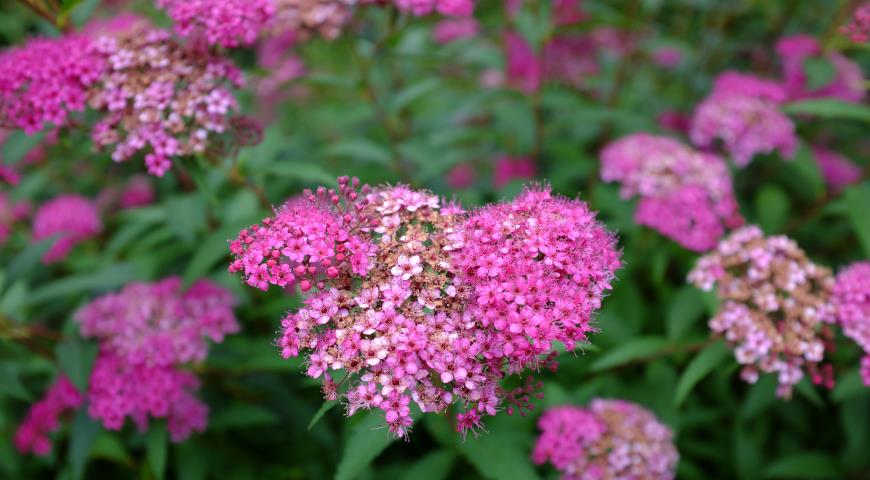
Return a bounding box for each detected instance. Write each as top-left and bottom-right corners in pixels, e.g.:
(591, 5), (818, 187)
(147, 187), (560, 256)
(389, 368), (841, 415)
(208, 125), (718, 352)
(335, 413), (393, 480)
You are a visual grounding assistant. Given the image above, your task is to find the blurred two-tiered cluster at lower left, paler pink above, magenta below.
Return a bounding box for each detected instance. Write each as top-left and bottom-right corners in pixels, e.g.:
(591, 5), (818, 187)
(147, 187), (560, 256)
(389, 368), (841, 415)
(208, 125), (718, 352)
(75, 277), (239, 441)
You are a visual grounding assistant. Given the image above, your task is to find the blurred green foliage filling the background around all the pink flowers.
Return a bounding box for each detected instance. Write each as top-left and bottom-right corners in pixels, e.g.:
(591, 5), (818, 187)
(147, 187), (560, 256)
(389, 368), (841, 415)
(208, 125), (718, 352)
(0, 0), (870, 480)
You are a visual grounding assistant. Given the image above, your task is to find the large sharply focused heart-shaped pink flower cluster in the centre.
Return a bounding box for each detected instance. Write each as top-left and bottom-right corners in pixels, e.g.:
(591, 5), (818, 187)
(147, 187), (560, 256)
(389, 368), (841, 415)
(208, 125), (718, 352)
(230, 177), (619, 436)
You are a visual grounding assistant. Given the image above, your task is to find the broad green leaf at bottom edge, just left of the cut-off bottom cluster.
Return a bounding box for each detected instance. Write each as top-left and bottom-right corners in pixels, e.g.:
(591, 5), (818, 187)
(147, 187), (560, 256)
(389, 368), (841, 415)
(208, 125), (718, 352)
(459, 432), (540, 480)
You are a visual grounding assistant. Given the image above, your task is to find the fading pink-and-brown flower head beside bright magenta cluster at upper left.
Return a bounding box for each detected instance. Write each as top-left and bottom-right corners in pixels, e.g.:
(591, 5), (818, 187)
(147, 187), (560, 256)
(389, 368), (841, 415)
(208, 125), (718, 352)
(89, 25), (242, 176)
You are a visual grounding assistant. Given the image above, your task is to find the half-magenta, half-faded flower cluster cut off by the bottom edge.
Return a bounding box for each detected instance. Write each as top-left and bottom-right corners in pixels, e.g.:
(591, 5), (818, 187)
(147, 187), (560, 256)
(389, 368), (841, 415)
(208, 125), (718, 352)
(532, 399), (679, 480)
